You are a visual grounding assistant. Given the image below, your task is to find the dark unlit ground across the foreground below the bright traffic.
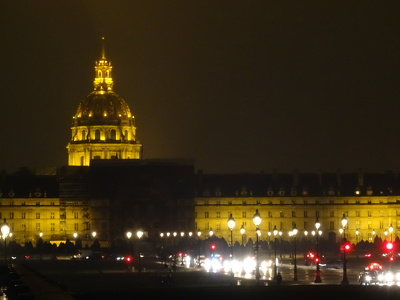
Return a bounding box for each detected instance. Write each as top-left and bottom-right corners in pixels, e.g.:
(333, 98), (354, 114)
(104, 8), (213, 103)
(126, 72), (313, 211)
(6, 261), (400, 300)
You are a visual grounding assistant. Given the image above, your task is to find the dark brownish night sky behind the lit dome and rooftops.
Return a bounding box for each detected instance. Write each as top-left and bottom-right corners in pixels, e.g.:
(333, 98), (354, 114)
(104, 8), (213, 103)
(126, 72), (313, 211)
(0, 0), (400, 173)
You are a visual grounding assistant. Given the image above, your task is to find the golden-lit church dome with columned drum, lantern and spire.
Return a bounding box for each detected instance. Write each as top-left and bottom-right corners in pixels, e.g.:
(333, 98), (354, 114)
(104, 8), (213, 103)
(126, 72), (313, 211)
(67, 39), (142, 166)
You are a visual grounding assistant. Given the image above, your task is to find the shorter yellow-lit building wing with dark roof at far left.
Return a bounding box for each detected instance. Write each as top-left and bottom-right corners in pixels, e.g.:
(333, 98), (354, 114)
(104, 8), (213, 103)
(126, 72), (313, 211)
(0, 171), (109, 245)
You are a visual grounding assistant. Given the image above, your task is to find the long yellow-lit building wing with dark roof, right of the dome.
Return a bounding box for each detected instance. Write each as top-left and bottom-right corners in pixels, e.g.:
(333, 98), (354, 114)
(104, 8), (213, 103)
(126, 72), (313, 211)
(195, 173), (400, 243)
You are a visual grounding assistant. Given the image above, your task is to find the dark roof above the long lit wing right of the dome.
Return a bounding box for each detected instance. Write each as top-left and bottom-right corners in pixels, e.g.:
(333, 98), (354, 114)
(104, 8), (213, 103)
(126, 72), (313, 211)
(196, 171), (400, 197)
